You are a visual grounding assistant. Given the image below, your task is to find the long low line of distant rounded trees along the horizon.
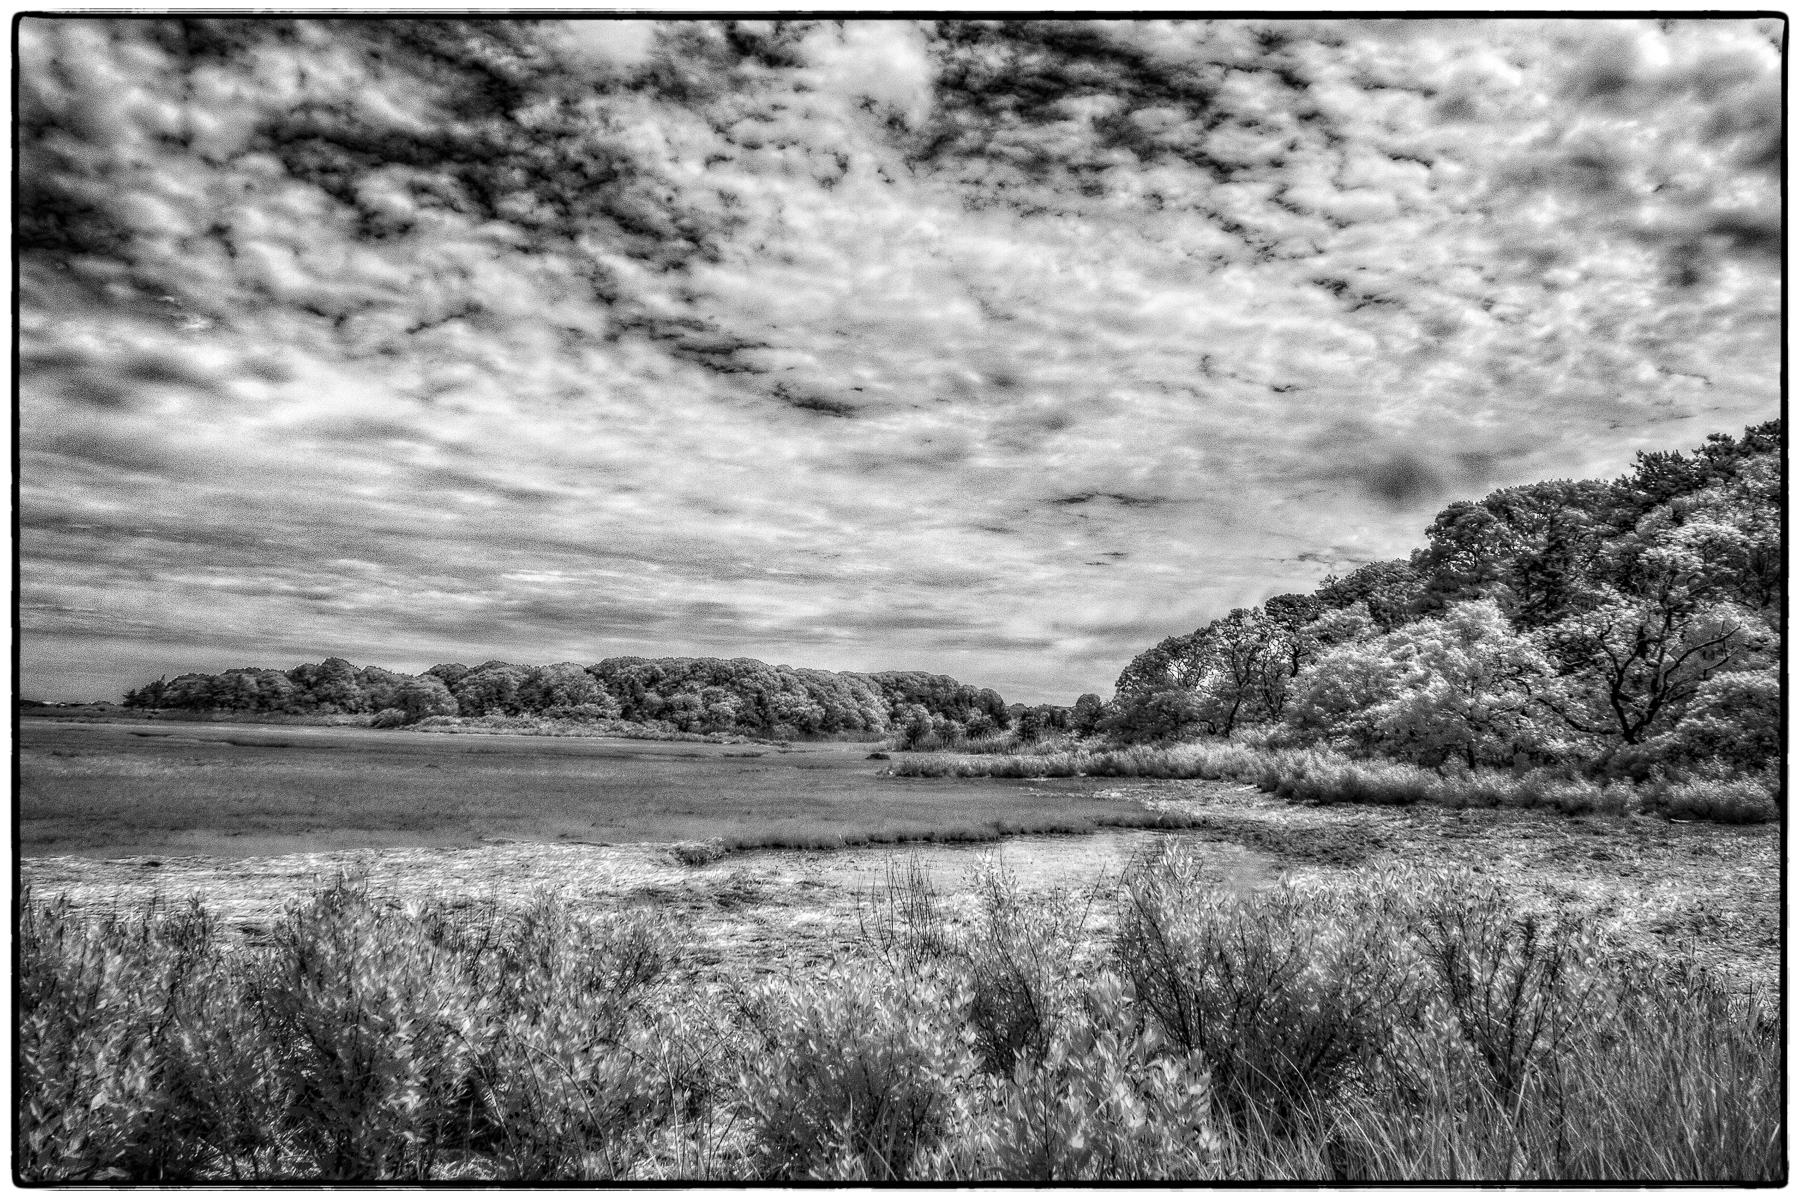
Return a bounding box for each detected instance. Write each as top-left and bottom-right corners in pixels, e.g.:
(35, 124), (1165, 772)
(124, 657), (1008, 738)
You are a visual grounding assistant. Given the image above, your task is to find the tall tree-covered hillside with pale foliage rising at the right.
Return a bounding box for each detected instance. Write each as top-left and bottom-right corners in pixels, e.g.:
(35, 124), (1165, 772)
(1102, 421), (1784, 788)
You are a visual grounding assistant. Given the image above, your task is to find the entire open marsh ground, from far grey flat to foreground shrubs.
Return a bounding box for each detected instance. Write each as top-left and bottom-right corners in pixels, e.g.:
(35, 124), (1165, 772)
(20, 721), (1786, 1180)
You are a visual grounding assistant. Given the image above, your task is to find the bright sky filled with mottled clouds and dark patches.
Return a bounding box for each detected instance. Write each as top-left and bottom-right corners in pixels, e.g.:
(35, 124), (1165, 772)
(16, 18), (1784, 703)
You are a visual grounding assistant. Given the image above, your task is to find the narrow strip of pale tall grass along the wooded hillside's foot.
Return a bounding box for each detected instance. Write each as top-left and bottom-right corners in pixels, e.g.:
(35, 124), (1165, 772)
(889, 741), (1780, 824)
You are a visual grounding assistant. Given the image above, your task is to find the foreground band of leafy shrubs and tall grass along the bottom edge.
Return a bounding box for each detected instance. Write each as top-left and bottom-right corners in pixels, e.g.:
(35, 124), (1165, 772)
(14, 846), (1784, 1182)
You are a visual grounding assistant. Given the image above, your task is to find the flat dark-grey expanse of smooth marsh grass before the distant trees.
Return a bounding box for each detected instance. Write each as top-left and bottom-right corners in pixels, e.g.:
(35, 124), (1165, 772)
(18, 718), (1209, 858)
